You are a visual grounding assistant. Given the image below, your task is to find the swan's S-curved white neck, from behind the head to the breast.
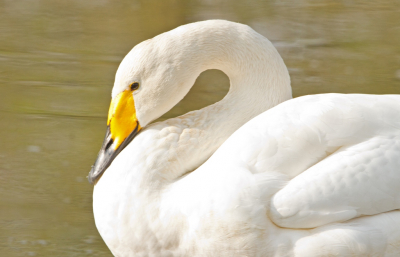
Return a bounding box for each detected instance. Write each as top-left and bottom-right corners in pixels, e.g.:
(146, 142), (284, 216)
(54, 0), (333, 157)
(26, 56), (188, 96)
(142, 23), (292, 180)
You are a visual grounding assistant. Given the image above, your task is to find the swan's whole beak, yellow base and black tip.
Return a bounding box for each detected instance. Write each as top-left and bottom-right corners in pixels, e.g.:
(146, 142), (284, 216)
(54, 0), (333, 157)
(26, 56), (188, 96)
(88, 90), (141, 184)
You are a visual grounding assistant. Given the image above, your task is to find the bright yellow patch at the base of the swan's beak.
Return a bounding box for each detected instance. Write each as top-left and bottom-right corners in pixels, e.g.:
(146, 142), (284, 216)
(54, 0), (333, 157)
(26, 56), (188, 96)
(107, 90), (141, 150)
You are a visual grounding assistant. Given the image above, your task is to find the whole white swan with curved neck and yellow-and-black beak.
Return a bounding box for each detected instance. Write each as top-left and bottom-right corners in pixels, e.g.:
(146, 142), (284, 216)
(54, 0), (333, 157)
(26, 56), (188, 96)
(88, 20), (400, 257)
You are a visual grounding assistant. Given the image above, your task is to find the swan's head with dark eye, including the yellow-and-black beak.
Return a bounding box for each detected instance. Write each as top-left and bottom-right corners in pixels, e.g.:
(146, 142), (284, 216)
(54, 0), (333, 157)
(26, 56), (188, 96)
(88, 31), (201, 183)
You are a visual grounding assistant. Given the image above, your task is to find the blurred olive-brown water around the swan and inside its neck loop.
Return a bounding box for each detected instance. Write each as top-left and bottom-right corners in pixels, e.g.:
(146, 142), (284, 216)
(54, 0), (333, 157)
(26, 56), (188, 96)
(0, 0), (400, 257)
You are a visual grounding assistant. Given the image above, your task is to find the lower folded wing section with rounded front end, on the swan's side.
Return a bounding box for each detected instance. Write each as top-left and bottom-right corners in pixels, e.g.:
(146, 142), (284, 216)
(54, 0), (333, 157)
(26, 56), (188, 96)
(270, 135), (400, 228)
